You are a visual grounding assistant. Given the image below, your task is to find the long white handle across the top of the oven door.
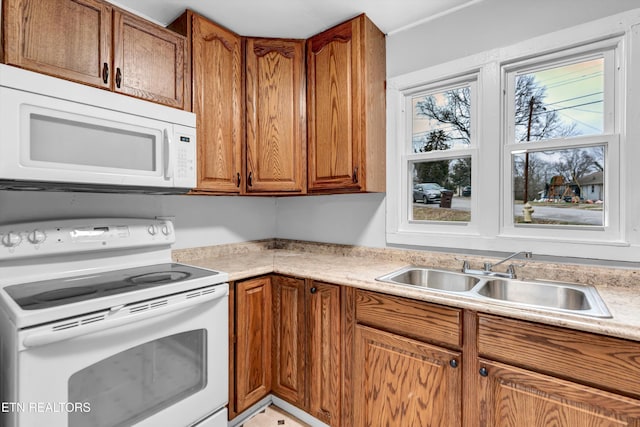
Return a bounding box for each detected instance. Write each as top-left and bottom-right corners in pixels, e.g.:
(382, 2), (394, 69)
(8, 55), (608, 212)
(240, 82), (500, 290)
(22, 286), (229, 348)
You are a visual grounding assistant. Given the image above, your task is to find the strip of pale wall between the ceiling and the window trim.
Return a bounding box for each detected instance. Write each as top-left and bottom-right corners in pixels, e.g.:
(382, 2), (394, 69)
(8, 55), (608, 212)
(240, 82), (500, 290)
(387, 0), (640, 77)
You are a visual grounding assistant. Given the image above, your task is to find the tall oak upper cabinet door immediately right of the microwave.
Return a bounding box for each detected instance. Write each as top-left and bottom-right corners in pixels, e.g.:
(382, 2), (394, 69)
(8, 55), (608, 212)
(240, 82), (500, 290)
(191, 14), (243, 193)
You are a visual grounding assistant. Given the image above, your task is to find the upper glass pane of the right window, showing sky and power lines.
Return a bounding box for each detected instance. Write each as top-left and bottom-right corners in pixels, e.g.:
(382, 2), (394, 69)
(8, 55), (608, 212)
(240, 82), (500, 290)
(515, 58), (604, 142)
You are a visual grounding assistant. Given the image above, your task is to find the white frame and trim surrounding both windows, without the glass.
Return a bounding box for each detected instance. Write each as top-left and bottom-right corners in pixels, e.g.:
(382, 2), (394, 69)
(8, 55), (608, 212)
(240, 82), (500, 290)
(386, 12), (640, 262)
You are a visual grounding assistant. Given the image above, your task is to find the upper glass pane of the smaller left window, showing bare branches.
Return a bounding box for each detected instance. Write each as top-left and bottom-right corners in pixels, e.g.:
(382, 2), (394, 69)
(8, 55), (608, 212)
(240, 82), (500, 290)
(411, 86), (471, 153)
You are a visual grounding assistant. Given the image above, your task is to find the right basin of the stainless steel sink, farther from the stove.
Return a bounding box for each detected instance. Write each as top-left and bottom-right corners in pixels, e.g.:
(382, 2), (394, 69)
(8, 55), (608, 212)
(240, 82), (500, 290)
(477, 279), (611, 317)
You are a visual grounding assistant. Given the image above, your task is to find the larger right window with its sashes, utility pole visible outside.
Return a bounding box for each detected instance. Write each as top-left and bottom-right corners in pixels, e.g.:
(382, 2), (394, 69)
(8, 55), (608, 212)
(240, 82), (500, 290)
(503, 46), (620, 240)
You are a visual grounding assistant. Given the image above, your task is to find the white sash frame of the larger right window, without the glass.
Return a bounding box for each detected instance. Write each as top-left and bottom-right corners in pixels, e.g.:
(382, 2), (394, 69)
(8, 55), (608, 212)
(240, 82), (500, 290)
(500, 43), (622, 243)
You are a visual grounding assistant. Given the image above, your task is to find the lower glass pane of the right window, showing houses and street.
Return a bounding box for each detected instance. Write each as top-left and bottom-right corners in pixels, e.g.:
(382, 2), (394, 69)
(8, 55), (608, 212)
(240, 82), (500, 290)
(512, 146), (606, 226)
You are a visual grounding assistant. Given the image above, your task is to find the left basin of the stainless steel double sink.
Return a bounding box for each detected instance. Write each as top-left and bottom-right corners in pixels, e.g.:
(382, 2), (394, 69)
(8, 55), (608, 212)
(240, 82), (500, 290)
(377, 267), (480, 292)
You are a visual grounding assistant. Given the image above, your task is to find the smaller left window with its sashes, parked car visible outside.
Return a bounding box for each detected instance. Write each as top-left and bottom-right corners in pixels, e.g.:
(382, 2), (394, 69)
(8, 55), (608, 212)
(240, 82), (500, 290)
(392, 73), (477, 236)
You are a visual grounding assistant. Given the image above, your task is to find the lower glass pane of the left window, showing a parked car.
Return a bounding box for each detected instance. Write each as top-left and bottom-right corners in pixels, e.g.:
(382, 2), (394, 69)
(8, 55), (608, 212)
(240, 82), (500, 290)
(410, 157), (471, 222)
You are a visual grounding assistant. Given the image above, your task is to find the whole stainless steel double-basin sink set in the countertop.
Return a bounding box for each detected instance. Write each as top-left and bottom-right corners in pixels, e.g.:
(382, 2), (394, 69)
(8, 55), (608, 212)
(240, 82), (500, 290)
(376, 267), (611, 317)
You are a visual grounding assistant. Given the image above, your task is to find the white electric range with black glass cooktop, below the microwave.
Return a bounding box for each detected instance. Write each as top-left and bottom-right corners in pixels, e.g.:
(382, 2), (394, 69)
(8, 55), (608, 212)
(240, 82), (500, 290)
(0, 218), (229, 427)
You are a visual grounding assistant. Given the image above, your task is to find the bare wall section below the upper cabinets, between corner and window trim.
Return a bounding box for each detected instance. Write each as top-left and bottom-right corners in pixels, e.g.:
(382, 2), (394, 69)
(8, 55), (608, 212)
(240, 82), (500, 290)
(276, 193), (386, 247)
